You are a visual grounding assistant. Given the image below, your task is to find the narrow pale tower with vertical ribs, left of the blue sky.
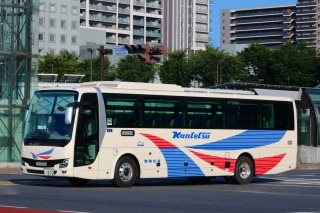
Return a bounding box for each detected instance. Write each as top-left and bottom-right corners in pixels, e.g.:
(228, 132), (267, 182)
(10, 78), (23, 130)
(163, 0), (212, 51)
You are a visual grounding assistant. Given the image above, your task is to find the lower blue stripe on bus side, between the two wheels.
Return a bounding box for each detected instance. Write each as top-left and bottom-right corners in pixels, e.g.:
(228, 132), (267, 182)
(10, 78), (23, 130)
(160, 148), (204, 178)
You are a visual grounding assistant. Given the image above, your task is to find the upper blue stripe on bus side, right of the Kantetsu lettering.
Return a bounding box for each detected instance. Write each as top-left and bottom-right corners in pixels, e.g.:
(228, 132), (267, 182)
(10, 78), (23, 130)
(188, 130), (286, 151)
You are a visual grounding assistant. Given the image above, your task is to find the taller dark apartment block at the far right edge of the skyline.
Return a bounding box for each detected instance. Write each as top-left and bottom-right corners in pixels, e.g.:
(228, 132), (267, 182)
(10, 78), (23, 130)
(296, 0), (320, 48)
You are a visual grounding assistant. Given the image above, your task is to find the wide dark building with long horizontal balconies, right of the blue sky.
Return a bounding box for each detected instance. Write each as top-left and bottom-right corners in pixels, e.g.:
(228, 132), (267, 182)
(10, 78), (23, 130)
(220, 5), (296, 47)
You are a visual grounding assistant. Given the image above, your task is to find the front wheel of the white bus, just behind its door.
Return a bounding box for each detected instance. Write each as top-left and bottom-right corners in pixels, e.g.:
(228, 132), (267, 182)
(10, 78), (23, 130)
(113, 156), (138, 187)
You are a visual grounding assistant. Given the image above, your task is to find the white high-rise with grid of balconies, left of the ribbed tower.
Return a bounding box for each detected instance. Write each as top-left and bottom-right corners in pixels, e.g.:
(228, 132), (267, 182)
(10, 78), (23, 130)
(80, 0), (163, 45)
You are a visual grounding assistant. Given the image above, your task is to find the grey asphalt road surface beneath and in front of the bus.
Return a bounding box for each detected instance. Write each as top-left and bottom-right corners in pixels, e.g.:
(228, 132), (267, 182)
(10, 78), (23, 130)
(0, 170), (320, 213)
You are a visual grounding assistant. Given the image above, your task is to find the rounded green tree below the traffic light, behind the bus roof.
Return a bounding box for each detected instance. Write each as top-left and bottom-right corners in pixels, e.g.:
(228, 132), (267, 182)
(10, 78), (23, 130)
(117, 55), (155, 82)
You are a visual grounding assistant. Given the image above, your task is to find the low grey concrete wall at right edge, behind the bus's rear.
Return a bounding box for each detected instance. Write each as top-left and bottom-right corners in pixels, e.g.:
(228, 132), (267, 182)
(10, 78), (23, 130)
(298, 145), (320, 163)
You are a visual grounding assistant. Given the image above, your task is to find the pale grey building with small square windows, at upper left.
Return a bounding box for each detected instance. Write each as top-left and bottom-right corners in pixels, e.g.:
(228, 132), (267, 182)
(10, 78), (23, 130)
(38, 0), (80, 55)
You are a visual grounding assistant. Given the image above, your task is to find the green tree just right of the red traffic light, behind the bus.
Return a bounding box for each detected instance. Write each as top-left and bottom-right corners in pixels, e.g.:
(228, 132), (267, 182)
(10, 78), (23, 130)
(159, 51), (190, 87)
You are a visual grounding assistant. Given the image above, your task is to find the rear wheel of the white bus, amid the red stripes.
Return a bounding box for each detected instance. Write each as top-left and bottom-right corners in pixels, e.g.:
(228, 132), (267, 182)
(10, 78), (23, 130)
(233, 156), (254, 185)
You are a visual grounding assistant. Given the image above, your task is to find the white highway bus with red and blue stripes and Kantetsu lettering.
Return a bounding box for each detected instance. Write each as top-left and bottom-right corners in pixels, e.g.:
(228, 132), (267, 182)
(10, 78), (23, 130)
(21, 82), (297, 187)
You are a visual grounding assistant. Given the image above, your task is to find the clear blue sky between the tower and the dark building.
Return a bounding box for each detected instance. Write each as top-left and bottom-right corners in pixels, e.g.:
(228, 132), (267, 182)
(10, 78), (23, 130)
(211, 0), (297, 47)
